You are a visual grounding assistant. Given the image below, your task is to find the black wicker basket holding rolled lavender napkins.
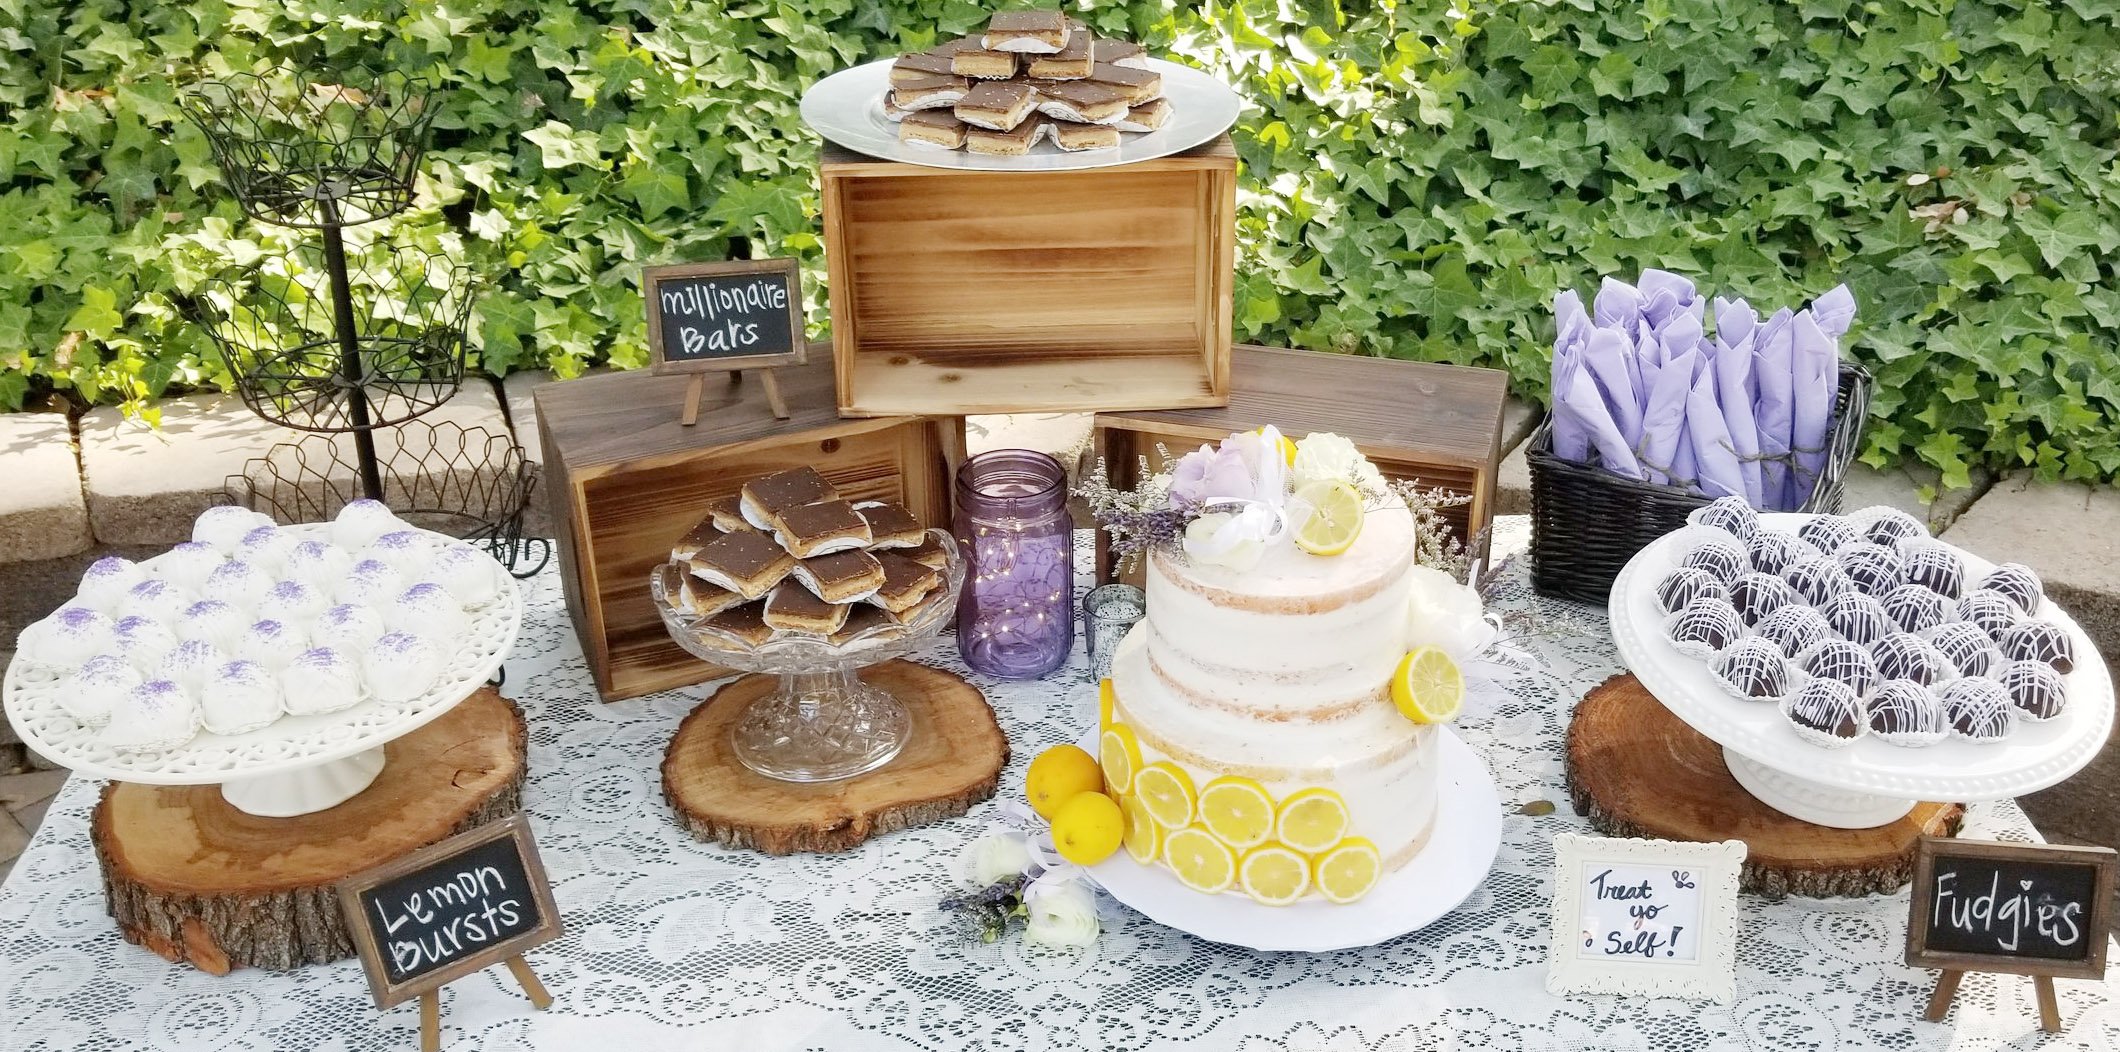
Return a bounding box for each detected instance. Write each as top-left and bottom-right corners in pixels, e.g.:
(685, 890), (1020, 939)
(1524, 361), (1874, 602)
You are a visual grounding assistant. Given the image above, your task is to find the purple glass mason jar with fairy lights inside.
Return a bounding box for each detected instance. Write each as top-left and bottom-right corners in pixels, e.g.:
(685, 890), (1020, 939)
(956, 450), (1075, 679)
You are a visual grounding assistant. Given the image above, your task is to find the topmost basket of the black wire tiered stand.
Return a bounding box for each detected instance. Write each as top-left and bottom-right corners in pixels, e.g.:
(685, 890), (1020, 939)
(182, 70), (439, 227)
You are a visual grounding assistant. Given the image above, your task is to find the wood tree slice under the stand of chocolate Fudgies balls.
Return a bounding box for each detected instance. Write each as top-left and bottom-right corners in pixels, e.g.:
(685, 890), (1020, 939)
(1567, 674), (1965, 897)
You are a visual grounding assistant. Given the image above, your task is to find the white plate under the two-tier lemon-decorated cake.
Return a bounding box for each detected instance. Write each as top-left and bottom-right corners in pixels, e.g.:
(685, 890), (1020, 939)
(1079, 727), (1501, 952)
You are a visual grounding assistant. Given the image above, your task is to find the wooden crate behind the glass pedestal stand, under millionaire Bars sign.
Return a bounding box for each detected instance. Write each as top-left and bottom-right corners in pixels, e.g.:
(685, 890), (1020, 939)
(536, 346), (965, 702)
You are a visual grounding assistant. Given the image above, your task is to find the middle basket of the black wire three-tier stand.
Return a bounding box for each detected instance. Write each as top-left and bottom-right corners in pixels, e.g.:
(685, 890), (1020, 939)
(195, 244), (477, 433)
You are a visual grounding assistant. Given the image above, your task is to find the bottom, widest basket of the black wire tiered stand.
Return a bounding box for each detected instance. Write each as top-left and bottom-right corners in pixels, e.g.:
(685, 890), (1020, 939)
(223, 420), (551, 577)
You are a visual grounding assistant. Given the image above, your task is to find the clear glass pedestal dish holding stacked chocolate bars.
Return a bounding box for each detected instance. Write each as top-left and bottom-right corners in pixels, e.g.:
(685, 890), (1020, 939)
(651, 530), (965, 783)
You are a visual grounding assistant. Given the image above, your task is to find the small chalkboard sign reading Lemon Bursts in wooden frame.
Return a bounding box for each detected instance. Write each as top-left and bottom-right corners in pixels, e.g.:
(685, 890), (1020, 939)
(339, 814), (560, 1007)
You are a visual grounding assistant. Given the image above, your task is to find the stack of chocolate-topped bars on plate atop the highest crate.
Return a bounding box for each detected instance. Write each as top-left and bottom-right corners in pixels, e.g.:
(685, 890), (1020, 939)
(884, 11), (1170, 157)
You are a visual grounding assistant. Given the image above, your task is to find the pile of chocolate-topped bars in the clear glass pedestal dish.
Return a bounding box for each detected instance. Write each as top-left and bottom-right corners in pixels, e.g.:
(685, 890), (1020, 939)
(664, 467), (950, 647)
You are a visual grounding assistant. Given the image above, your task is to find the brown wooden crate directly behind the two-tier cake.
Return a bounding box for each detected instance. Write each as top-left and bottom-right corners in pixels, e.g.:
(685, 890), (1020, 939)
(1094, 346), (1509, 583)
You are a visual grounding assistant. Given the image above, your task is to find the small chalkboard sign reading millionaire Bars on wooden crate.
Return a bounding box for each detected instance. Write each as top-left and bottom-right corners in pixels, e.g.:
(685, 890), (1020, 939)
(640, 259), (803, 373)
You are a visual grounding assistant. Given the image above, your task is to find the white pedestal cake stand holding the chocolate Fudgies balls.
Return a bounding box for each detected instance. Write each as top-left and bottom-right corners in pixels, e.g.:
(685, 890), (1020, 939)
(1611, 513), (2114, 829)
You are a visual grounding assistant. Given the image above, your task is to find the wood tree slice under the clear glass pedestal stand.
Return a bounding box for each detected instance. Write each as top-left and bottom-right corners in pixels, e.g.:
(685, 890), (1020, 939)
(664, 662), (1009, 855)
